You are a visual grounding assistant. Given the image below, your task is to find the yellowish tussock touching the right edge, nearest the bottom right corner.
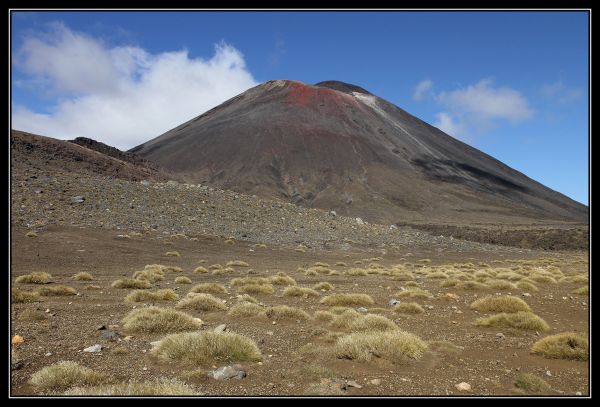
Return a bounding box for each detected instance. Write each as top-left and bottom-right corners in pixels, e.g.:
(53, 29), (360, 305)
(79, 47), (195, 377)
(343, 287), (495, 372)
(531, 332), (589, 360)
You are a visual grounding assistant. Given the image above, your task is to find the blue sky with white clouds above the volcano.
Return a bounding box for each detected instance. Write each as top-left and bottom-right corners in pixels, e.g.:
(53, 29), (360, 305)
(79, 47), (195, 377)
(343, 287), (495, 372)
(11, 12), (589, 204)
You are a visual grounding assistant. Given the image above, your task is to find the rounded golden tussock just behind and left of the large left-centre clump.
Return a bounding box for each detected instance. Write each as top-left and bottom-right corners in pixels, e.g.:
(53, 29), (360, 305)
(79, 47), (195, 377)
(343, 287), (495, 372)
(122, 307), (202, 333)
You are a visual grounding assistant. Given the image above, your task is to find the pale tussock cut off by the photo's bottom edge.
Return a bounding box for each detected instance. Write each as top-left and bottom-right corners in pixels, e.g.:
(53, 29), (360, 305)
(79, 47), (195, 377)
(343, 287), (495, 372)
(64, 378), (200, 396)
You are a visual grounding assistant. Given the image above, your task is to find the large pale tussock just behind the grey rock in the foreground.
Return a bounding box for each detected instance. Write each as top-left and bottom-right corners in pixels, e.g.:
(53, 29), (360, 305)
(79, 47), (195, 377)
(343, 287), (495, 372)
(151, 331), (262, 366)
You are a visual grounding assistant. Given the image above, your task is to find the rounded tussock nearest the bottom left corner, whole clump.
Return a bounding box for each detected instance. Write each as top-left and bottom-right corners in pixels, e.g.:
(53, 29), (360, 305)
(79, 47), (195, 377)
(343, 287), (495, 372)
(29, 361), (108, 393)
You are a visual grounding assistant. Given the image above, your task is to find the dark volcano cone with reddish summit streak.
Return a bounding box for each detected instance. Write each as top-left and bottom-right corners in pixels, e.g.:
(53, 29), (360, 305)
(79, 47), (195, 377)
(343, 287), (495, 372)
(131, 80), (587, 223)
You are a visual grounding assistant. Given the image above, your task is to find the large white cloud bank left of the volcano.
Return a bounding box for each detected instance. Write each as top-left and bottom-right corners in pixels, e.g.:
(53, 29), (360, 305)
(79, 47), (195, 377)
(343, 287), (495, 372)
(12, 24), (256, 149)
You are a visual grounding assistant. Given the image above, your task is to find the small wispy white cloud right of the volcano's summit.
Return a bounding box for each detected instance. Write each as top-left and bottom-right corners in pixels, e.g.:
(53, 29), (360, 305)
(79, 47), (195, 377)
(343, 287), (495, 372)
(414, 79), (533, 138)
